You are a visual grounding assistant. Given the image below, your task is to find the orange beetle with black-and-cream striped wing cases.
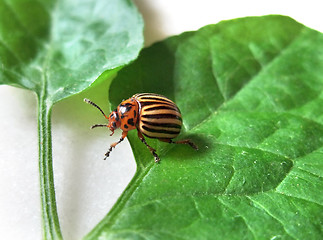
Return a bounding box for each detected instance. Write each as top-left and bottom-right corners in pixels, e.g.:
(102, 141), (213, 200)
(84, 93), (198, 162)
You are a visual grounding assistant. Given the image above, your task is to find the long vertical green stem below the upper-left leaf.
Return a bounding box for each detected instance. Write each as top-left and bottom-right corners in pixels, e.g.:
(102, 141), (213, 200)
(38, 96), (63, 240)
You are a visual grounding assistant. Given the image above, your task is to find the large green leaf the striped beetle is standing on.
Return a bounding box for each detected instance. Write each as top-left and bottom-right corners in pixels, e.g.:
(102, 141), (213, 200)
(86, 15), (323, 239)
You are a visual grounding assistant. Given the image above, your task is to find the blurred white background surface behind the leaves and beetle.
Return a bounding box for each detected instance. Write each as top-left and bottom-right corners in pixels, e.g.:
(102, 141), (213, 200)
(0, 0), (323, 240)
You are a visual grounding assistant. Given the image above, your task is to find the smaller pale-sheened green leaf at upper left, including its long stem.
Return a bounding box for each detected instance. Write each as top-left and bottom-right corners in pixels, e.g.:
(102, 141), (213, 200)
(0, 0), (143, 239)
